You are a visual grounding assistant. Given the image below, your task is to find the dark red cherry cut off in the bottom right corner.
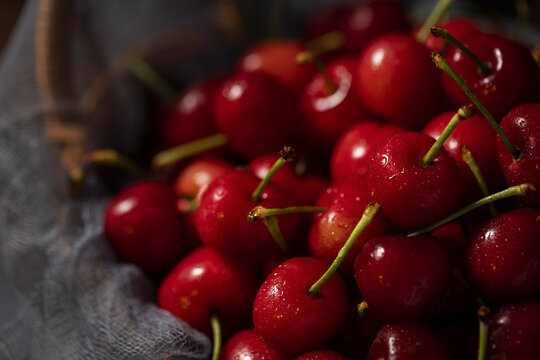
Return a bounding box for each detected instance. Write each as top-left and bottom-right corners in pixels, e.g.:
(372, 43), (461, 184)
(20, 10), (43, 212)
(486, 301), (540, 360)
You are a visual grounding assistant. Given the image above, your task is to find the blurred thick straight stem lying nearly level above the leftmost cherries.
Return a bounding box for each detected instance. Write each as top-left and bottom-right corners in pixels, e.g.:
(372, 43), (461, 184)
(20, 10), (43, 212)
(152, 134), (227, 168)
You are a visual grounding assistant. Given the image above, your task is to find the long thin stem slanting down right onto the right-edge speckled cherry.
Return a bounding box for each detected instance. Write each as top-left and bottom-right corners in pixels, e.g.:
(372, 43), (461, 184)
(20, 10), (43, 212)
(431, 52), (520, 160)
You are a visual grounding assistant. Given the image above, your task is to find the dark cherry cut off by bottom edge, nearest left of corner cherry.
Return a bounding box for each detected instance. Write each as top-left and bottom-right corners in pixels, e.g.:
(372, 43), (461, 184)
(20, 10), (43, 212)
(367, 321), (450, 360)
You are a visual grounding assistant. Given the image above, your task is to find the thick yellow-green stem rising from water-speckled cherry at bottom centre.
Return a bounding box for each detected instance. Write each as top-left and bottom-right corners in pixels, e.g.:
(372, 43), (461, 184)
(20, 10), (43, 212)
(307, 202), (381, 297)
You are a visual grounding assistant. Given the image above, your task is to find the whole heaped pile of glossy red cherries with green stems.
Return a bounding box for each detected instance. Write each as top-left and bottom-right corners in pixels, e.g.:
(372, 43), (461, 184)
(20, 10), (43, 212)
(97, 0), (540, 360)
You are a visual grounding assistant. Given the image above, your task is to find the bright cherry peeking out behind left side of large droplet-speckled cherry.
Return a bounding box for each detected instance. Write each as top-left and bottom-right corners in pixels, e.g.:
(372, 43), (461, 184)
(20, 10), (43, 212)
(330, 120), (406, 182)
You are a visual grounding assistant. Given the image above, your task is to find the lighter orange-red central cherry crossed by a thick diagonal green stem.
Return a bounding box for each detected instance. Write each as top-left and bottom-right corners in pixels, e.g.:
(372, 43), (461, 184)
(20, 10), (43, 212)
(309, 182), (395, 274)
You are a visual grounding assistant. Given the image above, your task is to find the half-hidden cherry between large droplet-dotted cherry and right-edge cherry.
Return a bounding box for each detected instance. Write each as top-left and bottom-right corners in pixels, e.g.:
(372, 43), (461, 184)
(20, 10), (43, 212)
(422, 111), (506, 198)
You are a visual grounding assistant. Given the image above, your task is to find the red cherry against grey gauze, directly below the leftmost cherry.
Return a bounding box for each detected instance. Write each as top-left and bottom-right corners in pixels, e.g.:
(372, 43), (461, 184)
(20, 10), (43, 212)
(158, 247), (257, 335)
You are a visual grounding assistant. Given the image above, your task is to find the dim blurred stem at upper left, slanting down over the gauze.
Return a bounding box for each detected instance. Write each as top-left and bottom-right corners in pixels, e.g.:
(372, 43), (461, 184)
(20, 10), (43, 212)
(129, 58), (179, 106)
